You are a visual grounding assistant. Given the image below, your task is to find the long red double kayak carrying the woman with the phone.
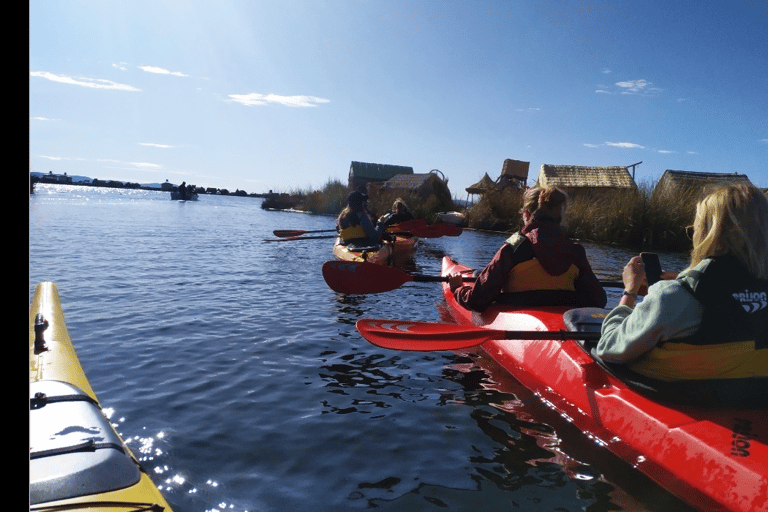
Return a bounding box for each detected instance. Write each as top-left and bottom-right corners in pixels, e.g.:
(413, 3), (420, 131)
(442, 257), (768, 512)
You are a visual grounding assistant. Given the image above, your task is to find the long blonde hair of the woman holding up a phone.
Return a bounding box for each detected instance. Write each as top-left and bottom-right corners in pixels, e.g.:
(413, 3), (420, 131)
(691, 183), (768, 279)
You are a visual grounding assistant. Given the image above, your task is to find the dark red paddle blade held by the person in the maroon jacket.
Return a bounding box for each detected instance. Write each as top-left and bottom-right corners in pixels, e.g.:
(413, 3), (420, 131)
(323, 261), (413, 294)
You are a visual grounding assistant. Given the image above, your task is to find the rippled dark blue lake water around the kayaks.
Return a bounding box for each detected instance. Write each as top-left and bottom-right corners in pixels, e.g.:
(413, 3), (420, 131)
(29, 184), (686, 512)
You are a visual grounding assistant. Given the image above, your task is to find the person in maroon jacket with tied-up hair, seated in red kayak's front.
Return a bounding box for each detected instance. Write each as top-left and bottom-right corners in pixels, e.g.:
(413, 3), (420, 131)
(448, 186), (607, 311)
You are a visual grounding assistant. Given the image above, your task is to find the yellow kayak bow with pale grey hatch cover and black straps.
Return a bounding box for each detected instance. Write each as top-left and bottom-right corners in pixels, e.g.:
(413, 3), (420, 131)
(29, 282), (171, 512)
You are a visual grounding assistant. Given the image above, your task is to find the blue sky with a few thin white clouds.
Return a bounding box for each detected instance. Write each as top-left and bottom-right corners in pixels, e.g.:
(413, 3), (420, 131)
(29, 0), (768, 199)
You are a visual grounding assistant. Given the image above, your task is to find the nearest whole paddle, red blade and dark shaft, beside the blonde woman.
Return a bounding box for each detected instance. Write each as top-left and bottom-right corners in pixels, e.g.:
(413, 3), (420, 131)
(355, 318), (600, 352)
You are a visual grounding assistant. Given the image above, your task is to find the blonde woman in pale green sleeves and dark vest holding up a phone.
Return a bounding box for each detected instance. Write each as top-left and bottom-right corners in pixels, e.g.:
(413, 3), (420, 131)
(594, 184), (768, 406)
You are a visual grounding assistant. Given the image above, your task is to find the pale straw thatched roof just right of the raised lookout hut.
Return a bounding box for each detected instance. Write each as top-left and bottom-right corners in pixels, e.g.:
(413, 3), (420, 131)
(538, 164), (637, 189)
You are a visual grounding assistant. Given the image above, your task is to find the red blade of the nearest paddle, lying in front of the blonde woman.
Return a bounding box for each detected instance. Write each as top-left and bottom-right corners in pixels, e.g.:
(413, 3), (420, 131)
(355, 318), (504, 351)
